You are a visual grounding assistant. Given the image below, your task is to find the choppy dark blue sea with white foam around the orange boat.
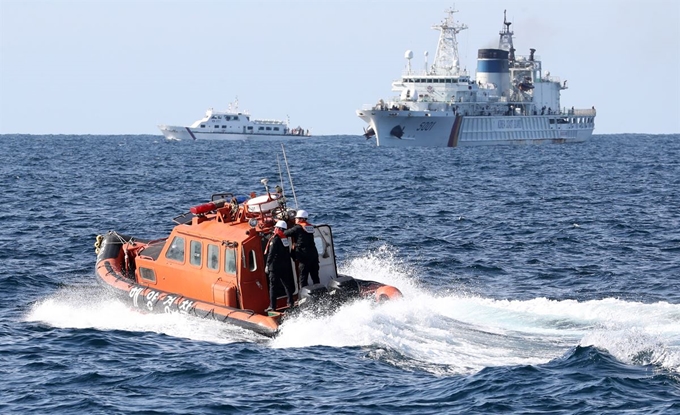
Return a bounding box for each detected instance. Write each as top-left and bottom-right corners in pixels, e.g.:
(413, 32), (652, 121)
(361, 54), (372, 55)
(0, 134), (680, 414)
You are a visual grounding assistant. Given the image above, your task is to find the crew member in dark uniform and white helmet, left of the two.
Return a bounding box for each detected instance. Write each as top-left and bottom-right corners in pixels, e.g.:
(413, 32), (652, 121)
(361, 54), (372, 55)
(264, 220), (295, 311)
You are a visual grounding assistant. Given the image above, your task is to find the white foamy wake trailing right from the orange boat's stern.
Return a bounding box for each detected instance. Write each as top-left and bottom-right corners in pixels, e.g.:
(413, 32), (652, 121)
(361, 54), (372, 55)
(272, 247), (680, 373)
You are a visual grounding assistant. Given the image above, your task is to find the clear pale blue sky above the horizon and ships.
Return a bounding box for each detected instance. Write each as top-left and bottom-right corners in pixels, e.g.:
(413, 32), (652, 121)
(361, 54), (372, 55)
(0, 0), (680, 135)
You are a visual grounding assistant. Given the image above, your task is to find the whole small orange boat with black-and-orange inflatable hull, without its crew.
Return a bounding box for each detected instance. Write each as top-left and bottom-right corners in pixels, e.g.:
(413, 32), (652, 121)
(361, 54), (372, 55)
(95, 179), (402, 337)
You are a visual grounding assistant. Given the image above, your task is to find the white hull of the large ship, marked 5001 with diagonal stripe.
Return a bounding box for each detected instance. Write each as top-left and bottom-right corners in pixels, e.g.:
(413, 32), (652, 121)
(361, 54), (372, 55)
(357, 110), (595, 147)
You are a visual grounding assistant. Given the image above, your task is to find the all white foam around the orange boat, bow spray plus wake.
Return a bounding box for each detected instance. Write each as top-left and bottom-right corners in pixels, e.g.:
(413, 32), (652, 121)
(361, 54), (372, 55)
(25, 247), (680, 374)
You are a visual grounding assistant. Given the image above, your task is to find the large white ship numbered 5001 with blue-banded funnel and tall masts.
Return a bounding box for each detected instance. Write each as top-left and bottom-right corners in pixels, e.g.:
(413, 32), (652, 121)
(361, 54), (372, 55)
(357, 9), (595, 147)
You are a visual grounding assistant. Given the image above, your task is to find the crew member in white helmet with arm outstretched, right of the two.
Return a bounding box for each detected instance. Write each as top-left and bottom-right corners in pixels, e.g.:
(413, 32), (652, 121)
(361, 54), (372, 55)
(284, 209), (319, 287)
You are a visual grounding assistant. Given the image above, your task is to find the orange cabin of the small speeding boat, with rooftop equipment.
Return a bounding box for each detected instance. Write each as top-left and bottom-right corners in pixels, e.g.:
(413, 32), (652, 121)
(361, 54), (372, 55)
(128, 191), (337, 313)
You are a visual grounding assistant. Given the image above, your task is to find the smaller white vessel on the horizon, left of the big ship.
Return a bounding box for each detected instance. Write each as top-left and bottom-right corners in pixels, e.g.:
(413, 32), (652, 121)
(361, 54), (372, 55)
(158, 99), (310, 140)
